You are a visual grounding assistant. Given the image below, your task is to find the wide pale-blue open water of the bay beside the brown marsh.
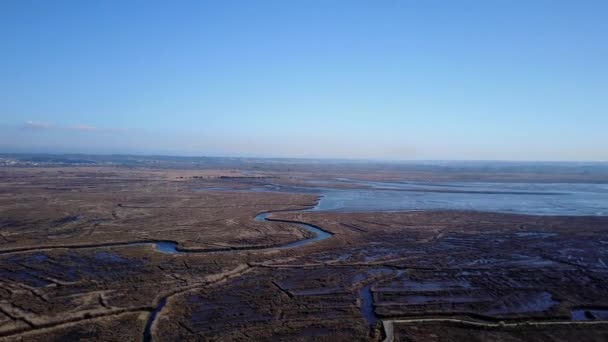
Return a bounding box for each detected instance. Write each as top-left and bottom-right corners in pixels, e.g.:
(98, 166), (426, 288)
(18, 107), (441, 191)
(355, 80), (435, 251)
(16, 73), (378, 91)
(304, 179), (608, 216)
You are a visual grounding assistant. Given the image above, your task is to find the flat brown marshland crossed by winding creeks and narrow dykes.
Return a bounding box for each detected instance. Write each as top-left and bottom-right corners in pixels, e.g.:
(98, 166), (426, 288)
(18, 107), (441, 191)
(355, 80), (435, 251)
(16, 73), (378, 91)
(0, 166), (608, 341)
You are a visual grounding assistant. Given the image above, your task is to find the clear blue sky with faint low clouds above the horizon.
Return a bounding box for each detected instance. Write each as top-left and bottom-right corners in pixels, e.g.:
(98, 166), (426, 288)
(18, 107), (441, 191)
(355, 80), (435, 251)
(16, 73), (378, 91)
(0, 0), (608, 160)
